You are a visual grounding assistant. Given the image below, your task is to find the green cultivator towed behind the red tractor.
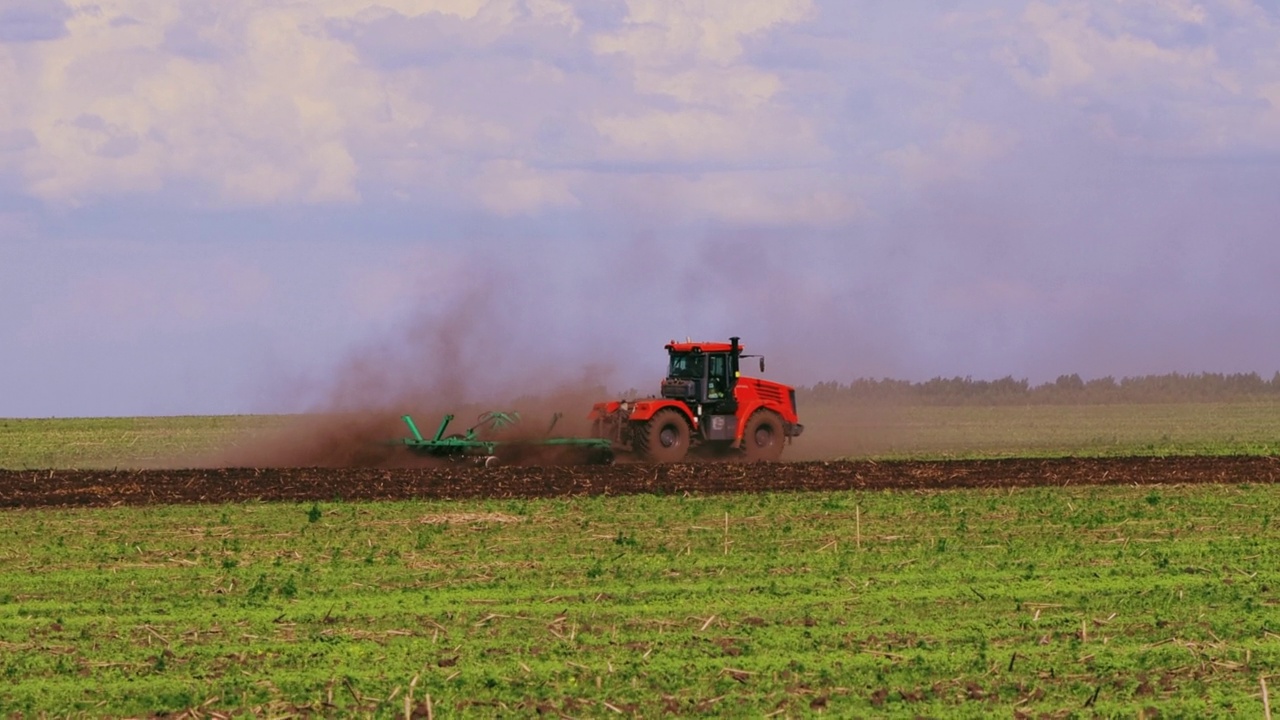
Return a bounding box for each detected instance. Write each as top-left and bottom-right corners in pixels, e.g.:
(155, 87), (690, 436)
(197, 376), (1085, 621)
(392, 413), (613, 468)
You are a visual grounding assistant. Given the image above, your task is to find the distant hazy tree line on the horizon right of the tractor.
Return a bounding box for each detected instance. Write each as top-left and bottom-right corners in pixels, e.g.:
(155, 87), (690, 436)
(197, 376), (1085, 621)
(796, 373), (1280, 406)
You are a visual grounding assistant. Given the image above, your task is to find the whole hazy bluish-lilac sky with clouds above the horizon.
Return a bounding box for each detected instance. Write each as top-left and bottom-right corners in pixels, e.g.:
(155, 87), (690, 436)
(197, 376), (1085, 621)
(0, 0), (1280, 416)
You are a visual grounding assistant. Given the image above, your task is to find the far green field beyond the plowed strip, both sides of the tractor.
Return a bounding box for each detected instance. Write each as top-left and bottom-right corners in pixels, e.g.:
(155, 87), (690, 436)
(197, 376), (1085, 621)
(0, 401), (1280, 469)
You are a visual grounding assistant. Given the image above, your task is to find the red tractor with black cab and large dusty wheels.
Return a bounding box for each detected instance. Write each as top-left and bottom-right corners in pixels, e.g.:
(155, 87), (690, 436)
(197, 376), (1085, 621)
(590, 337), (804, 462)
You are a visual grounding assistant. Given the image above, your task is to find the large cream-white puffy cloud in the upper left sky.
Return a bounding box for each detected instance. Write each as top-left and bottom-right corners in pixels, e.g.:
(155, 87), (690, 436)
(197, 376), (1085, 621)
(9, 1), (387, 204)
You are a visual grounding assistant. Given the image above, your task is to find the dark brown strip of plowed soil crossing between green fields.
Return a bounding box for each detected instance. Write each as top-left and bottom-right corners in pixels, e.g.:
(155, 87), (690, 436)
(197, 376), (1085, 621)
(0, 456), (1280, 507)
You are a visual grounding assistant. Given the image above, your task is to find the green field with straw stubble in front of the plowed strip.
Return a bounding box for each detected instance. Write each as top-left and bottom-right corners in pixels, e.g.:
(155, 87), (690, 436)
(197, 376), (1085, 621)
(0, 478), (1280, 717)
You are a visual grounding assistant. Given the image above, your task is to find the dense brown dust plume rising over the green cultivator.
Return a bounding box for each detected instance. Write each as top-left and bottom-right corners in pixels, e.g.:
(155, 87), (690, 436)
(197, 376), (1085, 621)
(199, 273), (619, 468)
